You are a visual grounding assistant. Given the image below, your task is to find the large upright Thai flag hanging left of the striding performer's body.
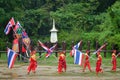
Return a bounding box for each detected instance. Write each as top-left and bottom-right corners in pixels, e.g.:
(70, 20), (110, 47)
(74, 49), (84, 65)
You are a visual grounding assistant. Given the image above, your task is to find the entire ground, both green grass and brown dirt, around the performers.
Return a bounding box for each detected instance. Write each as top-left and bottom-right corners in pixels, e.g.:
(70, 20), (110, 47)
(0, 53), (120, 80)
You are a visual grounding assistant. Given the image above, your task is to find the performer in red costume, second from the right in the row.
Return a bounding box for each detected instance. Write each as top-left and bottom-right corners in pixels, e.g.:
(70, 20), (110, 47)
(96, 51), (103, 75)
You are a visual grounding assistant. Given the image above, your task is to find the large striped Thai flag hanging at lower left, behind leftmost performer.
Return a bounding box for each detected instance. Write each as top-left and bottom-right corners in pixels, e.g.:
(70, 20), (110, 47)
(7, 48), (17, 68)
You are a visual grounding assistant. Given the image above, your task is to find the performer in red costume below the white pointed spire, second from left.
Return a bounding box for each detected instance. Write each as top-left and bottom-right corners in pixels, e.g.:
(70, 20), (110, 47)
(58, 52), (67, 73)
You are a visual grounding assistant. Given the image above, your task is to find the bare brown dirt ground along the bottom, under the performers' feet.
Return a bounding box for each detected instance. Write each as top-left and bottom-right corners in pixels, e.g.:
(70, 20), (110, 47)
(0, 64), (120, 80)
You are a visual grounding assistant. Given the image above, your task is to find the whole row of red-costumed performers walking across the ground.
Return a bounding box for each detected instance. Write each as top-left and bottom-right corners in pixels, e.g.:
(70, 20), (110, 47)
(27, 50), (117, 75)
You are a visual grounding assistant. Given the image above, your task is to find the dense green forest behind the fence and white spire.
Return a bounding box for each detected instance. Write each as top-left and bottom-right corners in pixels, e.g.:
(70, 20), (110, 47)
(0, 0), (120, 50)
